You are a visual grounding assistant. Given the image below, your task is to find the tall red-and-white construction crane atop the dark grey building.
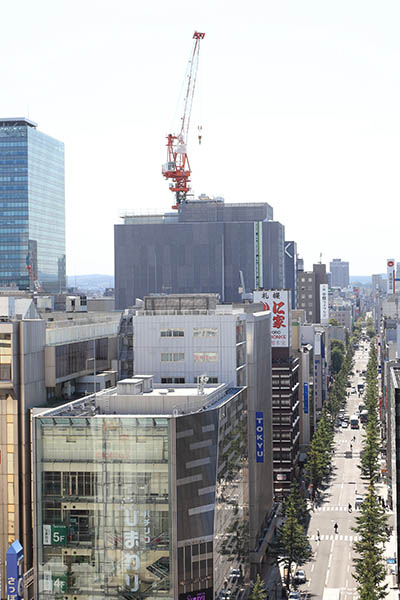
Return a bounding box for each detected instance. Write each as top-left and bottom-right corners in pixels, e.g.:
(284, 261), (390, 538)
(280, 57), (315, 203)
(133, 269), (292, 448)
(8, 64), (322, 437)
(162, 31), (206, 209)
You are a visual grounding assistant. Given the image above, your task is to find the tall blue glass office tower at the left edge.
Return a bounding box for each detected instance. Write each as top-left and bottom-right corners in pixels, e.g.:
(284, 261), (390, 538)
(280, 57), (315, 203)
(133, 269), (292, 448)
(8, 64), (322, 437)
(0, 118), (66, 293)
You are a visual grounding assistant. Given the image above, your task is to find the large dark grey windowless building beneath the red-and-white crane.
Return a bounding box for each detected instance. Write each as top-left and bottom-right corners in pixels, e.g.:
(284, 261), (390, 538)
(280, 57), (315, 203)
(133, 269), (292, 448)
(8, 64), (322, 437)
(114, 198), (285, 309)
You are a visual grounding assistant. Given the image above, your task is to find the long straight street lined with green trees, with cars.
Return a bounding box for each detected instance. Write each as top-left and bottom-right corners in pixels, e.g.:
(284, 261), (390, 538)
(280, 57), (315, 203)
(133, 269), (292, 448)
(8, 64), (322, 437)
(299, 342), (369, 600)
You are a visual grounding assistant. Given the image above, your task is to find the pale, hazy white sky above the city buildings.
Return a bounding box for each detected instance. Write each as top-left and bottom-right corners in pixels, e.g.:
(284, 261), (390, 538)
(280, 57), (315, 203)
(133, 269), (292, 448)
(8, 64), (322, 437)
(0, 0), (400, 275)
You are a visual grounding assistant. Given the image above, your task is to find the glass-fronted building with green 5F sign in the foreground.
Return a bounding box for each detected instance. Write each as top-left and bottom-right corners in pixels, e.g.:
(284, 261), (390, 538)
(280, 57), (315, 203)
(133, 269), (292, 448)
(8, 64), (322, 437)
(33, 376), (250, 600)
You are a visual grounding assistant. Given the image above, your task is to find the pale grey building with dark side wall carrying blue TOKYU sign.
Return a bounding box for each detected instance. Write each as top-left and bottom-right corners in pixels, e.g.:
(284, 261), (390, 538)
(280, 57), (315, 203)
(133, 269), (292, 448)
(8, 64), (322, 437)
(123, 294), (274, 574)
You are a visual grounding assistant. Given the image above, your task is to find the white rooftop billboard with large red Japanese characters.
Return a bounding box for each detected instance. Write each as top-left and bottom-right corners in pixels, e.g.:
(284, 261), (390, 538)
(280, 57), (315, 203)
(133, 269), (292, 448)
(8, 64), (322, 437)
(253, 290), (291, 348)
